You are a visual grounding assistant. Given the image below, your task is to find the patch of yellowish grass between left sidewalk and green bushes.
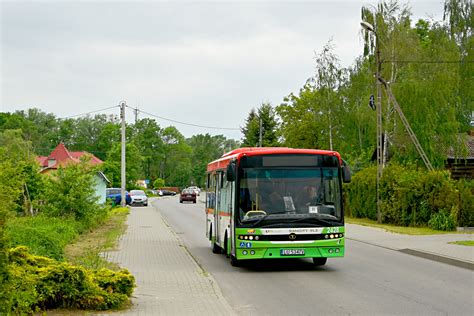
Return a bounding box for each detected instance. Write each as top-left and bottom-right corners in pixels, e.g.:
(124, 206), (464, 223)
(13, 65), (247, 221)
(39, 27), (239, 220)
(64, 207), (129, 271)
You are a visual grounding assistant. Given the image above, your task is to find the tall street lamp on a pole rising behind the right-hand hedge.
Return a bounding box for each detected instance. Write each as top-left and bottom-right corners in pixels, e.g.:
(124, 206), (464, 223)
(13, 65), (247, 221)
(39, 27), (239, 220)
(360, 21), (383, 223)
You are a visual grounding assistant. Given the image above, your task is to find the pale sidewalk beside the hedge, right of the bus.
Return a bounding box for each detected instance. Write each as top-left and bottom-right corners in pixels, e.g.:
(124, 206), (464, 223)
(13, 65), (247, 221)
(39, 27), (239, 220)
(346, 224), (474, 270)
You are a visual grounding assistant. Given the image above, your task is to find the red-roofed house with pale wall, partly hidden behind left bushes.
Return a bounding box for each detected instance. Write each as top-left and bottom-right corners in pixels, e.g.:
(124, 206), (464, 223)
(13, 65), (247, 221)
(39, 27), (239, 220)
(36, 143), (110, 203)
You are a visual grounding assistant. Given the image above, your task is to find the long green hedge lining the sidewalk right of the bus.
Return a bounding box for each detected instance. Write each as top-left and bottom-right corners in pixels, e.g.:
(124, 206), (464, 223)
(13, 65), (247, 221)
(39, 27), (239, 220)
(346, 164), (474, 230)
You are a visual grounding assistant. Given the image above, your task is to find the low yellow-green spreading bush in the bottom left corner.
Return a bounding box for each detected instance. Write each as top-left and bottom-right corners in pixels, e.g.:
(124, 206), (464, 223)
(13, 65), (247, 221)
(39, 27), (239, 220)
(6, 247), (135, 314)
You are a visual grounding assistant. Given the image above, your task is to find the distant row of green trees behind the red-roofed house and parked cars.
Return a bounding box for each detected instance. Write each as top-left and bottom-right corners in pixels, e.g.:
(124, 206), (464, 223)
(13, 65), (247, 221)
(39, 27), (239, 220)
(0, 109), (239, 188)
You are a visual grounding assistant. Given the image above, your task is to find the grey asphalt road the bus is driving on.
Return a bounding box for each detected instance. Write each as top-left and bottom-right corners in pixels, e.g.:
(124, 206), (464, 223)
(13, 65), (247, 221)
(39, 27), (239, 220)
(153, 197), (474, 315)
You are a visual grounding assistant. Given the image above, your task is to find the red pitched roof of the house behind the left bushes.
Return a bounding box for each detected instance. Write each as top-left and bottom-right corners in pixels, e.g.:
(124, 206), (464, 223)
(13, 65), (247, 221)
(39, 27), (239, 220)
(36, 143), (103, 171)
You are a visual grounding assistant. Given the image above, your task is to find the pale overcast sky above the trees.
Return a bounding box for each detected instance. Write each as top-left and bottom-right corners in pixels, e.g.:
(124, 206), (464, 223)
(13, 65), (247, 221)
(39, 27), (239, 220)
(0, 0), (444, 139)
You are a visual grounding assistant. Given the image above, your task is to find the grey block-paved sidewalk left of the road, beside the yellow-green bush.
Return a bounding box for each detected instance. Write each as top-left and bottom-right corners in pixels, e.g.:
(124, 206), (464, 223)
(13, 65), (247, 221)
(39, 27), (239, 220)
(106, 207), (234, 315)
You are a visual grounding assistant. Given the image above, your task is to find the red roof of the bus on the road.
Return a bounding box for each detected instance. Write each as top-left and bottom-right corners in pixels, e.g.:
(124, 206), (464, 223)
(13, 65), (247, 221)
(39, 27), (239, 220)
(207, 147), (342, 171)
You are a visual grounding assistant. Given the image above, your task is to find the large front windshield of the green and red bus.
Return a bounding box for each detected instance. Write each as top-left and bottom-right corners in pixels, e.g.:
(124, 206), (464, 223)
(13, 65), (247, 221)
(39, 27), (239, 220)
(237, 167), (342, 227)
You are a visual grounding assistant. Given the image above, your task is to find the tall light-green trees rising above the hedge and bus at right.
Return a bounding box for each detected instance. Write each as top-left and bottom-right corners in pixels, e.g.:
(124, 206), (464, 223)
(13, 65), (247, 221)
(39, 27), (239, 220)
(276, 2), (474, 167)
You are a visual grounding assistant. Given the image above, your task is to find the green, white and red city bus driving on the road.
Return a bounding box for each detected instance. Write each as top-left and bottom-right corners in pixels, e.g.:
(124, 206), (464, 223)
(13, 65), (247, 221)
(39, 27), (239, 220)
(205, 147), (351, 266)
